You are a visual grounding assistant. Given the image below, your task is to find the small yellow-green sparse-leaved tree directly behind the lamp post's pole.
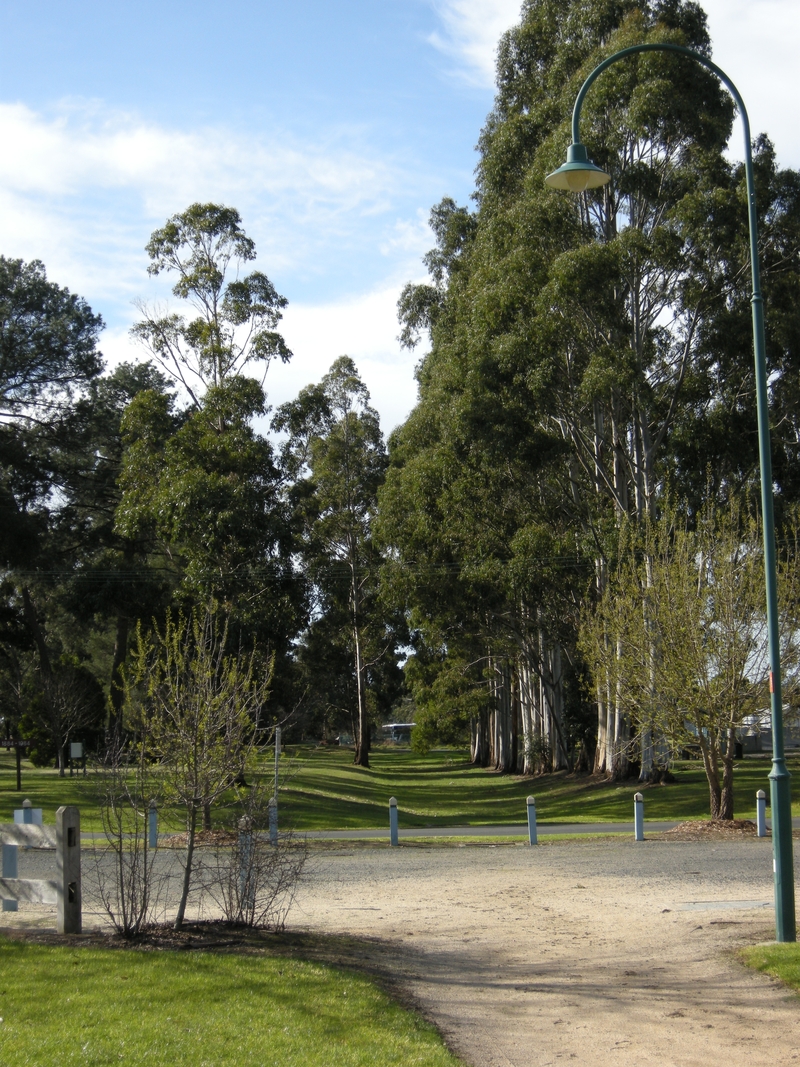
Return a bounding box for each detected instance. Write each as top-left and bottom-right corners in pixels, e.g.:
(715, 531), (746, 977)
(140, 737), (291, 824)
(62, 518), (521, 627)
(582, 505), (800, 818)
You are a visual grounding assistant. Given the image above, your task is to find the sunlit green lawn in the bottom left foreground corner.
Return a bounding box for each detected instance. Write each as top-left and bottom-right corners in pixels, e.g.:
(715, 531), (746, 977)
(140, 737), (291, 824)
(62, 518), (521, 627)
(0, 940), (461, 1067)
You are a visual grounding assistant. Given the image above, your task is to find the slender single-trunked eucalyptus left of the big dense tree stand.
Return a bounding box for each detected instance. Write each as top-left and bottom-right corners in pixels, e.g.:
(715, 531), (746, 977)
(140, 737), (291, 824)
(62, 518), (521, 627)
(272, 355), (399, 765)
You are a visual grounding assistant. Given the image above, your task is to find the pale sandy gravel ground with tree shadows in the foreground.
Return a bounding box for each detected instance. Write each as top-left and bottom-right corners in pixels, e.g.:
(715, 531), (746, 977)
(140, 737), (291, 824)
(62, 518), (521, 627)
(3, 838), (800, 1067)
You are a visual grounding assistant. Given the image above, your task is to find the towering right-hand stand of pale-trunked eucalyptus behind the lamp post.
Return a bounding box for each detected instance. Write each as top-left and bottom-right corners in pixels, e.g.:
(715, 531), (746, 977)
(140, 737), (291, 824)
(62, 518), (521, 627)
(379, 0), (800, 814)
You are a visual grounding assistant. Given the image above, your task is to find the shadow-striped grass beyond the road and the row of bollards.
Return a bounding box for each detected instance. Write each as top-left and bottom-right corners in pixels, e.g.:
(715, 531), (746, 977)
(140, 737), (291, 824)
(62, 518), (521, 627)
(0, 746), (800, 831)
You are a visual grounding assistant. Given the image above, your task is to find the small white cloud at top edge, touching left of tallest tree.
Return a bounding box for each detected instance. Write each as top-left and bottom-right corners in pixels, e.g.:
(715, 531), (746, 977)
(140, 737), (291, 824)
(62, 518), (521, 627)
(429, 0), (522, 87)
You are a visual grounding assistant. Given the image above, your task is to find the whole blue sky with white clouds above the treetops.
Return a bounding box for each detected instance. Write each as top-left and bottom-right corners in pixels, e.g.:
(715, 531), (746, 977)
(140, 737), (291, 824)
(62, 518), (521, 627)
(0, 0), (800, 430)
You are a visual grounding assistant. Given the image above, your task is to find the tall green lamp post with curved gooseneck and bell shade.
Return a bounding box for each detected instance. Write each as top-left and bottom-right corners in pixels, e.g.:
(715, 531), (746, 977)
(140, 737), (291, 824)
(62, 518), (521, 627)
(545, 44), (797, 941)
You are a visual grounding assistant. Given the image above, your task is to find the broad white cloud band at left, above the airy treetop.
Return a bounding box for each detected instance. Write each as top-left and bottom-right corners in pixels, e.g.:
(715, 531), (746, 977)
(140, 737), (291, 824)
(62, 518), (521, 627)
(0, 101), (413, 304)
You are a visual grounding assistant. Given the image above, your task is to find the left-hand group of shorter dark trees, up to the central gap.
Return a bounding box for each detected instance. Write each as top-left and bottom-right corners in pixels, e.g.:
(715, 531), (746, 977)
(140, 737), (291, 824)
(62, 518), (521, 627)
(0, 204), (402, 773)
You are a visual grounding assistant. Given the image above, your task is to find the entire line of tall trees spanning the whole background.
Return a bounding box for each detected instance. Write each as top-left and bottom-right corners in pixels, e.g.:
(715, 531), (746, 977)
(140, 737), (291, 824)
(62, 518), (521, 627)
(0, 0), (800, 814)
